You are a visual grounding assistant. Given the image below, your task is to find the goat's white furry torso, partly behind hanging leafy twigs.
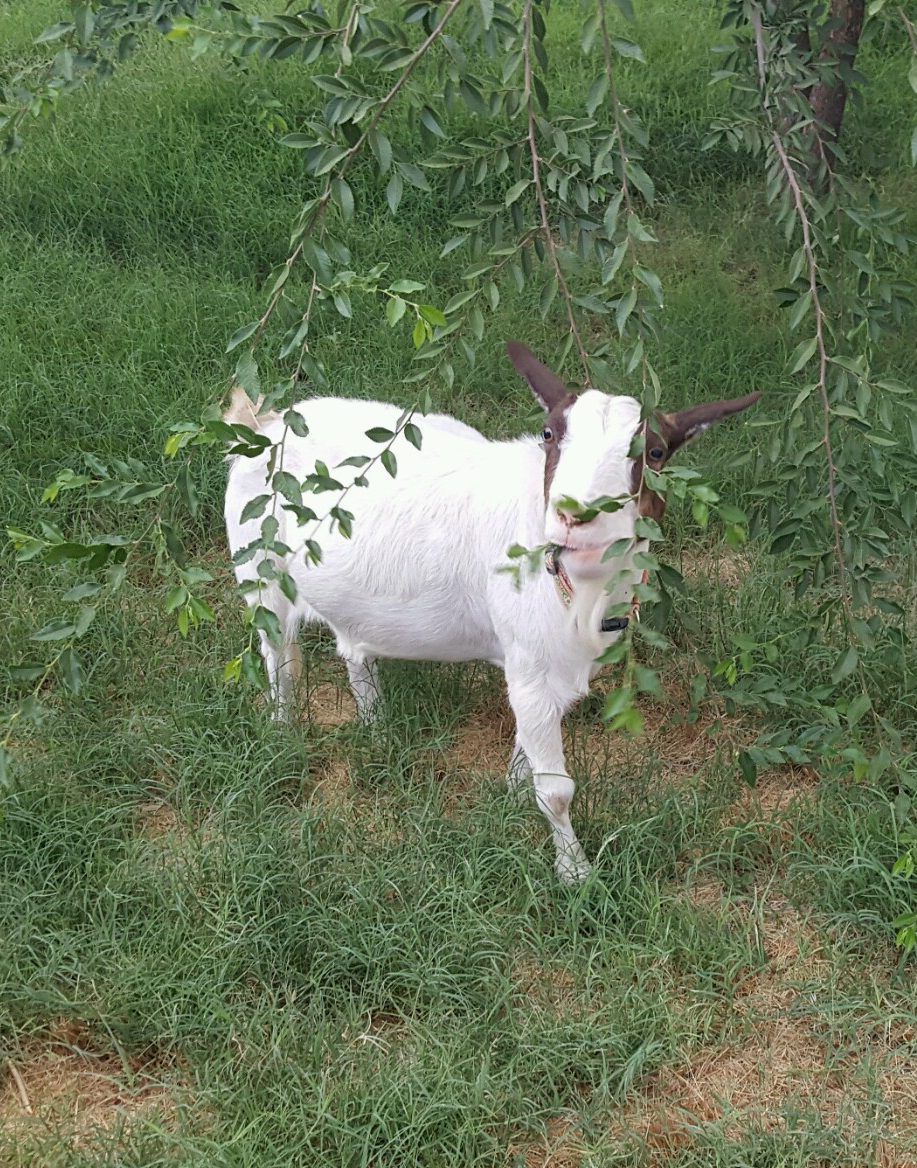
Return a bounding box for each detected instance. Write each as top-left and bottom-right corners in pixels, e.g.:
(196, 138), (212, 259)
(227, 398), (543, 660)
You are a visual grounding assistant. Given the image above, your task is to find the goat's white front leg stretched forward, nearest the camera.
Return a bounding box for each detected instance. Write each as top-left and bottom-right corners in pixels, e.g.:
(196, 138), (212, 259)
(506, 670), (592, 884)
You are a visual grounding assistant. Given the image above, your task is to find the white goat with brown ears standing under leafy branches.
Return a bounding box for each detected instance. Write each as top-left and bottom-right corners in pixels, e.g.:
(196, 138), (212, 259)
(225, 343), (759, 882)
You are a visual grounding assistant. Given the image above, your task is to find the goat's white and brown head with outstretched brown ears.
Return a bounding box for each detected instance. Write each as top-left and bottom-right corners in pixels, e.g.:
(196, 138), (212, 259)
(507, 341), (760, 577)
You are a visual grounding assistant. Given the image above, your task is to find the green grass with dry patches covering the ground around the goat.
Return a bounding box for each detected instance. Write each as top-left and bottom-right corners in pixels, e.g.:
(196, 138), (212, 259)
(0, 0), (917, 1168)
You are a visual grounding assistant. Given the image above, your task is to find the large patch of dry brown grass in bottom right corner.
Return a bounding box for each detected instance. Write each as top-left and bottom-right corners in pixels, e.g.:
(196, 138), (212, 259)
(611, 878), (917, 1153)
